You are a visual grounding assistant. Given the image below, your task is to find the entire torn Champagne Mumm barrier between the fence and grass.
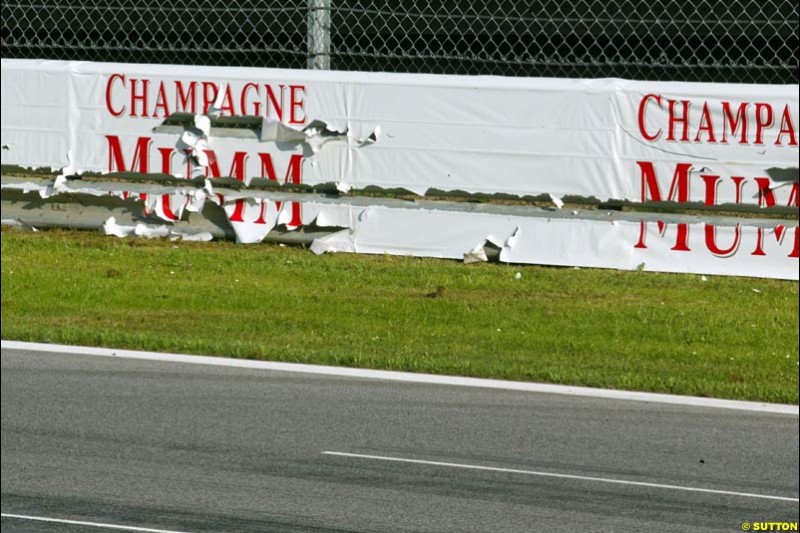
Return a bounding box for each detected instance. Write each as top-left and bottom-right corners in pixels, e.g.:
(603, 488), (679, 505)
(1, 59), (800, 280)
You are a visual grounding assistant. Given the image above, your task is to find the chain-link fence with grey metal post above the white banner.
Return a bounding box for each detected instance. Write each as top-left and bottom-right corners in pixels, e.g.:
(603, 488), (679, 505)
(0, 0), (798, 83)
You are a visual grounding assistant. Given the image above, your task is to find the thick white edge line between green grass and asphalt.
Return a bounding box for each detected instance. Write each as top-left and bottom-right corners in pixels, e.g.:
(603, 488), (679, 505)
(1, 340), (800, 416)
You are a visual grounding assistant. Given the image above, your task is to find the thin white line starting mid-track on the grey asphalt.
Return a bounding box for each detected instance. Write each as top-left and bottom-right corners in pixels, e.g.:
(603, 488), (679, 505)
(322, 451), (800, 502)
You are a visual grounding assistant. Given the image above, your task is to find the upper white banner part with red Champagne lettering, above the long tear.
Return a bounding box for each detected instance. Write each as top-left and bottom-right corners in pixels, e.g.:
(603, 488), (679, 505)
(2, 59), (798, 207)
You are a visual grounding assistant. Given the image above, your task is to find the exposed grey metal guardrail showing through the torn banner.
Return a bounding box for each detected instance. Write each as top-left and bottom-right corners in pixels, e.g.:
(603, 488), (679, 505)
(2, 173), (798, 233)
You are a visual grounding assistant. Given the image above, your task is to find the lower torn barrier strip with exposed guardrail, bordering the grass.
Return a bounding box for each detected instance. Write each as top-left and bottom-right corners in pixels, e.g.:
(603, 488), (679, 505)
(2, 177), (800, 280)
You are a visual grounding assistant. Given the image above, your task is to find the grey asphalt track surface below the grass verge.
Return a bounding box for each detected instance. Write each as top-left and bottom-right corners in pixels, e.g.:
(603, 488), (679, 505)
(2, 348), (798, 533)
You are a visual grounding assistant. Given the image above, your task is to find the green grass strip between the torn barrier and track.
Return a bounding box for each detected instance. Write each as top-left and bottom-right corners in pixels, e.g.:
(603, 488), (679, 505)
(2, 229), (798, 404)
